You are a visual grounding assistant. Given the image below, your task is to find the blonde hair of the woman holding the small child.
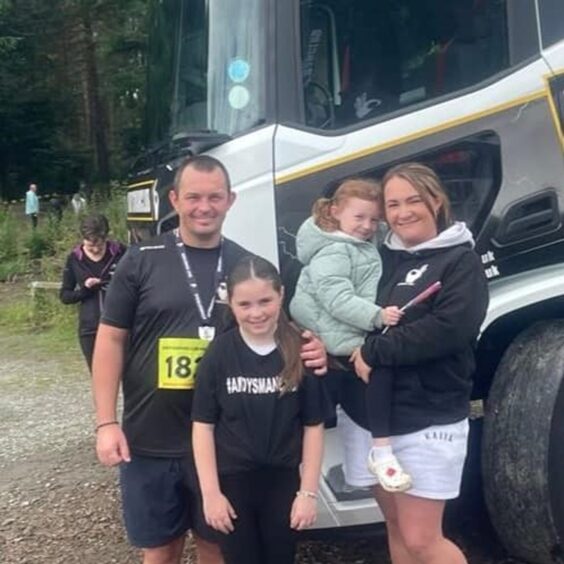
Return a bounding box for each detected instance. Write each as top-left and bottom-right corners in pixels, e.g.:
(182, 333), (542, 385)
(382, 163), (452, 233)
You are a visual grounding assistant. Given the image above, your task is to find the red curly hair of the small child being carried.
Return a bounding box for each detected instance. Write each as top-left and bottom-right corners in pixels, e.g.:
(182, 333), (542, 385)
(311, 178), (381, 231)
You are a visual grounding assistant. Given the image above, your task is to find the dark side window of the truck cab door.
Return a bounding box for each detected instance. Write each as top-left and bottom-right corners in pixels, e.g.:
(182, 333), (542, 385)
(300, 0), (512, 129)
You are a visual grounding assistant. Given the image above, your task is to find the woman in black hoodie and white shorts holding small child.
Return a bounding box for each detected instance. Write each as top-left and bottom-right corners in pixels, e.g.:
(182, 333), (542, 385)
(352, 163), (488, 564)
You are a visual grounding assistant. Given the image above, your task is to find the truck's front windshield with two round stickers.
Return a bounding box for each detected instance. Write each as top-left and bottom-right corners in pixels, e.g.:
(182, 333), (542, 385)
(147, 0), (267, 144)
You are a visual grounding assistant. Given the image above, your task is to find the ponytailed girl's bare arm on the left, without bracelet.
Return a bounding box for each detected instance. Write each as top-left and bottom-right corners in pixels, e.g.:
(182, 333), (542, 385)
(192, 421), (237, 534)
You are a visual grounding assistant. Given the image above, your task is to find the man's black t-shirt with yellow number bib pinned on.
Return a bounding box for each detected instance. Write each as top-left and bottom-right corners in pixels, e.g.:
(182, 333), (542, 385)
(101, 233), (249, 457)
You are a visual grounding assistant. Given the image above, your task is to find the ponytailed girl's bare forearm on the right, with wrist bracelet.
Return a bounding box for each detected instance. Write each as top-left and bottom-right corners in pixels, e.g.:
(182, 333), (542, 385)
(290, 423), (324, 530)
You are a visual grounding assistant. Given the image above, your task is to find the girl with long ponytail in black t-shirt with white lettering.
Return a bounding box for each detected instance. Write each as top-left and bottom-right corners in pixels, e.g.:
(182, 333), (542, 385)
(192, 256), (328, 564)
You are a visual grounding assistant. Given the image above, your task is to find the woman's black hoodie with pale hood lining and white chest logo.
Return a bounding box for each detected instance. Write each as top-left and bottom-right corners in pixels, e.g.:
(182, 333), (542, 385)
(362, 223), (488, 435)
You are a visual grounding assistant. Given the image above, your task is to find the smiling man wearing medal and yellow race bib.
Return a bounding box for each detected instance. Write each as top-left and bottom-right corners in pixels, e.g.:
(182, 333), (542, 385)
(93, 155), (325, 564)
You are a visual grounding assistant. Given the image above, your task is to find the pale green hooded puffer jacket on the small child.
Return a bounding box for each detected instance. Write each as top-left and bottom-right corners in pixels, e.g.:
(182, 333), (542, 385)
(290, 217), (382, 355)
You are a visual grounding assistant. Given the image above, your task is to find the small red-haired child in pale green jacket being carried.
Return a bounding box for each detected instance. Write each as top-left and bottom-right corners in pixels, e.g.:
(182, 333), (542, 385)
(290, 178), (411, 491)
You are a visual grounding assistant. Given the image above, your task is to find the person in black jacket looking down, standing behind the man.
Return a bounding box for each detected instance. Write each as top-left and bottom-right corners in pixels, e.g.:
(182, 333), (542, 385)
(60, 214), (126, 370)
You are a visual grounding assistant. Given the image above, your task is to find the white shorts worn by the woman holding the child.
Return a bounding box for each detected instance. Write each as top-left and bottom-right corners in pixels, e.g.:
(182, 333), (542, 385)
(339, 410), (469, 500)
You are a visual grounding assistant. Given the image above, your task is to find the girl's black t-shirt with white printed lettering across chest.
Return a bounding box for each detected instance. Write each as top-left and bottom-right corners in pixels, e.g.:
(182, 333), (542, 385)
(192, 328), (330, 475)
